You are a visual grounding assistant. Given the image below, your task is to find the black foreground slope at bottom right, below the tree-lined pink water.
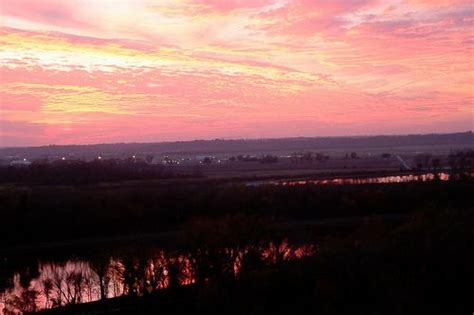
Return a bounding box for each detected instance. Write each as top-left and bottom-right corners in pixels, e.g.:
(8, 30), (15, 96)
(7, 208), (474, 314)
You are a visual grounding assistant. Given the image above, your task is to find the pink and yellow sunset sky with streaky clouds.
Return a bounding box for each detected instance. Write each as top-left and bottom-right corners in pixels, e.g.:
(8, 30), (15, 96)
(0, 0), (474, 146)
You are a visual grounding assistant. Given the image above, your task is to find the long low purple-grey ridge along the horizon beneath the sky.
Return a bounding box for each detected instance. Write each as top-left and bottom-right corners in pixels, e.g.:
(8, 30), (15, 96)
(0, 131), (474, 157)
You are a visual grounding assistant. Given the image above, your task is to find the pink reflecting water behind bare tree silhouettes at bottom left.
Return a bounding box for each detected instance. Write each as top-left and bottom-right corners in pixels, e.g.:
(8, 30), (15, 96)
(0, 240), (315, 314)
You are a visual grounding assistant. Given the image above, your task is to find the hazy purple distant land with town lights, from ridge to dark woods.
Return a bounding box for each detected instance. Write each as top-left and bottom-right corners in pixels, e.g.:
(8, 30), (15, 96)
(0, 132), (474, 183)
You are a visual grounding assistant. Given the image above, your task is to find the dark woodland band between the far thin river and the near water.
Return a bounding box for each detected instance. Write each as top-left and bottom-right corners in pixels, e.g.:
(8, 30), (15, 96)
(0, 178), (473, 248)
